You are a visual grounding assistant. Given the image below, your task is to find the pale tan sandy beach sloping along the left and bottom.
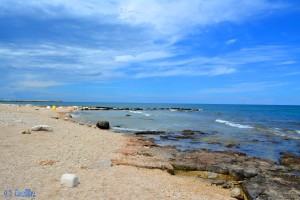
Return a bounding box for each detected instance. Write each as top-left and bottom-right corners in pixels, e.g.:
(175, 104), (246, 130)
(0, 104), (232, 199)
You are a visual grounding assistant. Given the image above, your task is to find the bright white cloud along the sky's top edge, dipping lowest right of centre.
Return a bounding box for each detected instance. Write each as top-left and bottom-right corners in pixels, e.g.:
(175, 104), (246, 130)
(0, 0), (286, 40)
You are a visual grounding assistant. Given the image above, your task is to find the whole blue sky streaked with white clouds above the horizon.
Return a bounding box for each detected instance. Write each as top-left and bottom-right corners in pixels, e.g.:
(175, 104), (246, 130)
(0, 0), (300, 105)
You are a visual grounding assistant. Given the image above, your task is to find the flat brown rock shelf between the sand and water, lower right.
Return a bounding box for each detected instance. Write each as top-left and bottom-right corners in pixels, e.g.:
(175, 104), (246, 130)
(112, 135), (300, 199)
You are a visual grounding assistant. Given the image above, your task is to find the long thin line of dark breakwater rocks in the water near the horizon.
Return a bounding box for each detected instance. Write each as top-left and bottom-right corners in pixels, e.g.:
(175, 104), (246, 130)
(78, 106), (202, 111)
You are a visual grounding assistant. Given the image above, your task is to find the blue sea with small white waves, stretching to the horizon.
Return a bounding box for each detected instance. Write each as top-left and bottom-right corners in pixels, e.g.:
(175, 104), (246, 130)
(2, 102), (300, 162)
